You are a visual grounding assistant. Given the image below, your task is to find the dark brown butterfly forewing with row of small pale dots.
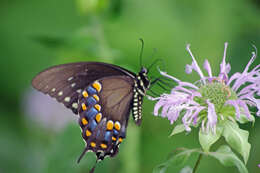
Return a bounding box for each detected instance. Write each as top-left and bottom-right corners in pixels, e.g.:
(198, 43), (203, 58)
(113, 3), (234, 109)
(32, 62), (135, 114)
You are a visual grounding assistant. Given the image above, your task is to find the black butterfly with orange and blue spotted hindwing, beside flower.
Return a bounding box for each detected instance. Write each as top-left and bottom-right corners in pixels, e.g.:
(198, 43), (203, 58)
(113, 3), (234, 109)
(32, 62), (150, 168)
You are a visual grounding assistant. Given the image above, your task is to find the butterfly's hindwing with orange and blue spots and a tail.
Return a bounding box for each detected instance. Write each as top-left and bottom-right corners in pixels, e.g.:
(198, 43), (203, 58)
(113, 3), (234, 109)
(76, 76), (134, 160)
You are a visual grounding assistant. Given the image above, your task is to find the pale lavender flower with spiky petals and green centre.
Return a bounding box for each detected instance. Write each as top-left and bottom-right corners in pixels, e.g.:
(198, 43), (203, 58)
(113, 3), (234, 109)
(150, 43), (260, 133)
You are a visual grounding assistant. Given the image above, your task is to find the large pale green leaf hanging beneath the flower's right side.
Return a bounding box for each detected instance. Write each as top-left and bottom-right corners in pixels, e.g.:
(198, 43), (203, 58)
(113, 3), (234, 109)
(223, 121), (251, 163)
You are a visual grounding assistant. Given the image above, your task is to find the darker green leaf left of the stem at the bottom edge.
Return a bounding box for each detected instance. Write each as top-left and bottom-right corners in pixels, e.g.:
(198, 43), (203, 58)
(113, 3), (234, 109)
(153, 148), (197, 173)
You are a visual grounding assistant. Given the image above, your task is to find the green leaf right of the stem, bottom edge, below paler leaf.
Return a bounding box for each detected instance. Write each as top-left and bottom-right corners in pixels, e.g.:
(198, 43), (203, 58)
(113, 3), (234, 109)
(209, 145), (248, 173)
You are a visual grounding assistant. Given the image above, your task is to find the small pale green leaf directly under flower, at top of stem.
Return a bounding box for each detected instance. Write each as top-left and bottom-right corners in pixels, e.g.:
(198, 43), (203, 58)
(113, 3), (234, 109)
(199, 126), (223, 152)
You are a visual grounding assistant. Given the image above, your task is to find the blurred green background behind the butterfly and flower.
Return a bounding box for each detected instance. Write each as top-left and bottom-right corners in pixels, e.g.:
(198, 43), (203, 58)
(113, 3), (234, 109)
(0, 0), (260, 173)
